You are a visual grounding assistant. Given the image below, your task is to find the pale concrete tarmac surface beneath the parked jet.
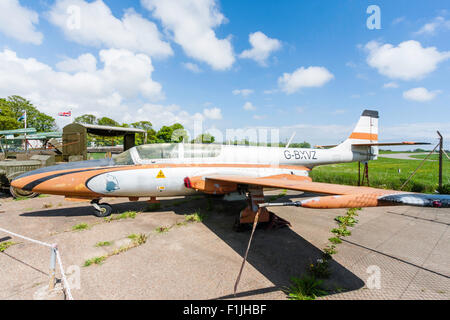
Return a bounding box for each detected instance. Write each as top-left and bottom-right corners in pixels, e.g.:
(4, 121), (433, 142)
(0, 191), (450, 300)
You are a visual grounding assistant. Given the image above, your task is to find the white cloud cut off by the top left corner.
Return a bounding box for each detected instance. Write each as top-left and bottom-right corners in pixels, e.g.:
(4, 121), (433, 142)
(0, 0), (44, 45)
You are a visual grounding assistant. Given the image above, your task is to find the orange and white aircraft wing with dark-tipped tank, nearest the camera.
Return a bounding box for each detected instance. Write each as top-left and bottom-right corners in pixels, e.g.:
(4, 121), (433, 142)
(193, 175), (450, 209)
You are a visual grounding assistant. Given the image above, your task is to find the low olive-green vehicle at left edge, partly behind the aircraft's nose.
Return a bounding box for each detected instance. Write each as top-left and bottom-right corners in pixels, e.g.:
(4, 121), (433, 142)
(0, 160), (42, 199)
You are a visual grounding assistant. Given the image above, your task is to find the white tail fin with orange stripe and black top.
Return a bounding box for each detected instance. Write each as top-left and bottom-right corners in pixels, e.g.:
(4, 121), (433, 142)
(335, 110), (379, 156)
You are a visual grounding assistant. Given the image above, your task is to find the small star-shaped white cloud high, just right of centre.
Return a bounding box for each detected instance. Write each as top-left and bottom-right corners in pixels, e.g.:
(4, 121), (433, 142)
(239, 31), (281, 66)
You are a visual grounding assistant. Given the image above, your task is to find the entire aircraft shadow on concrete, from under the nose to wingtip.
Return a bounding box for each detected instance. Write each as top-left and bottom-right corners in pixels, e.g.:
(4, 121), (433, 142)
(21, 194), (364, 299)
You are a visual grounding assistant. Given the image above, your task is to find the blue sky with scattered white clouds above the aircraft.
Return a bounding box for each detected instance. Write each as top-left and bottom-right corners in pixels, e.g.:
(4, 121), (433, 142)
(0, 0), (450, 145)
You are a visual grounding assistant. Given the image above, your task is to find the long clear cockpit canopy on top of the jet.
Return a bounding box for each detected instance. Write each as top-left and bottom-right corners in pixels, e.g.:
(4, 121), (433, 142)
(114, 143), (222, 165)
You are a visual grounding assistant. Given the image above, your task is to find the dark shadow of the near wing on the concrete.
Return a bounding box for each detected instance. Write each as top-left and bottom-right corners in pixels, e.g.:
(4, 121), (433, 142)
(169, 195), (364, 299)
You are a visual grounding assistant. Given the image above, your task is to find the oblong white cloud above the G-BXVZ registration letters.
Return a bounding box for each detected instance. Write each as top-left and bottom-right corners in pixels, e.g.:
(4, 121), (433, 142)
(278, 67), (334, 94)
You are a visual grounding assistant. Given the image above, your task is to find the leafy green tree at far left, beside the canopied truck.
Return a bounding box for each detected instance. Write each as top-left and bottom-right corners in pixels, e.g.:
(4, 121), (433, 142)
(6, 96), (57, 132)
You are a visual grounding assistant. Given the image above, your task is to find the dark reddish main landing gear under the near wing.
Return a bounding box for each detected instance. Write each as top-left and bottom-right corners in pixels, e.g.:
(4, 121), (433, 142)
(234, 186), (291, 232)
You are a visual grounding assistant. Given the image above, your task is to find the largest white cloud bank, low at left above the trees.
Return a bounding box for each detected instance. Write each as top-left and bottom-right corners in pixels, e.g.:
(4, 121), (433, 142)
(0, 49), (163, 121)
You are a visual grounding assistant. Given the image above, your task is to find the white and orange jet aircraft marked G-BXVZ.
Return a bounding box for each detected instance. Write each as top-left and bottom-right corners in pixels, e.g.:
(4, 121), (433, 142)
(12, 110), (450, 223)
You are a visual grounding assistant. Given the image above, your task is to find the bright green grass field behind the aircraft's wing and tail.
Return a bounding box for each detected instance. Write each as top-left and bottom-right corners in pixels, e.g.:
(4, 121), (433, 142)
(310, 158), (450, 193)
